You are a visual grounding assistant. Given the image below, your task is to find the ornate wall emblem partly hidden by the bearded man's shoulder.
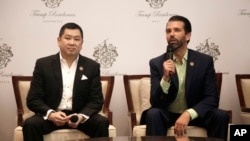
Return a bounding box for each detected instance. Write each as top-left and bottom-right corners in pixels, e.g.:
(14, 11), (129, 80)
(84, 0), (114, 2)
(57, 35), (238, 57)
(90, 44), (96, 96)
(196, 39), (220, 62)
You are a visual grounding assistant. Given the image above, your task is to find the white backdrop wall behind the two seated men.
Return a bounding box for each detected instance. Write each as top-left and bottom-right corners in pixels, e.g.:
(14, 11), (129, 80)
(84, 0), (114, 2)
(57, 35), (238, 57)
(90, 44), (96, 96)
(0, 0), (250, 141)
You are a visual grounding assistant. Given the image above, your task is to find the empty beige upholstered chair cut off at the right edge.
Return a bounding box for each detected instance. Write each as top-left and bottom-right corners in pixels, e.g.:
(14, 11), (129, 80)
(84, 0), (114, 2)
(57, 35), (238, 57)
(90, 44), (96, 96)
(235, 74), (250, 124)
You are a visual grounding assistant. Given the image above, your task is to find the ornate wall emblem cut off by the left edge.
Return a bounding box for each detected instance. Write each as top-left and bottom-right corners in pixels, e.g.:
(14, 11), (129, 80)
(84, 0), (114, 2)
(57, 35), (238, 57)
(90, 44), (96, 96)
(0, 44), (13, 69)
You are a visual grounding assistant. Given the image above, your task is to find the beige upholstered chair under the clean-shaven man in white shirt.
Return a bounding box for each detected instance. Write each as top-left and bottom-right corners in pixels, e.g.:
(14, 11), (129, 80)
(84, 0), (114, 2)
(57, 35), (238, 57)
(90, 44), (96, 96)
(12, 76), (116, 141)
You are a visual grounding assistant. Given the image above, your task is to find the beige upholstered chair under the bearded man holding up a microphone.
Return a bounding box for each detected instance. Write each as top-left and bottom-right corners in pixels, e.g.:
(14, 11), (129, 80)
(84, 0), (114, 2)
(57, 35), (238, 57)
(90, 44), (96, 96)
(123, 73), (232, 137)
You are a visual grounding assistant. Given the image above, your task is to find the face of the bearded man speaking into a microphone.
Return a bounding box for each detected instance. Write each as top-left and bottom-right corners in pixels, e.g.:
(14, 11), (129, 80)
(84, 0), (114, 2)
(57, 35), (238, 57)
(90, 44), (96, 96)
(166, 21), (191, 48)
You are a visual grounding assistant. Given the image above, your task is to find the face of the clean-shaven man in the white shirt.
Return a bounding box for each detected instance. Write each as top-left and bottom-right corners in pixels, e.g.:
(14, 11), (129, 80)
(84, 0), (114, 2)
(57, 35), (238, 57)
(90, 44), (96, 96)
(57, 29), (83, 57)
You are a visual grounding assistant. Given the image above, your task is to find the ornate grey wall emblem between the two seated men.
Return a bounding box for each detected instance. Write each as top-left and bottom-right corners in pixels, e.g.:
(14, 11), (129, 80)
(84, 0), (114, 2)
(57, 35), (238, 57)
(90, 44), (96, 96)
(93, 40), (118, 68)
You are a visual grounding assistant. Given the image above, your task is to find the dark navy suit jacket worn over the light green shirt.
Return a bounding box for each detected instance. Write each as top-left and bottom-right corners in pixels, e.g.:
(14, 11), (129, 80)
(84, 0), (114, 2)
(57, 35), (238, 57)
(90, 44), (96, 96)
(147, 49), (219, 117)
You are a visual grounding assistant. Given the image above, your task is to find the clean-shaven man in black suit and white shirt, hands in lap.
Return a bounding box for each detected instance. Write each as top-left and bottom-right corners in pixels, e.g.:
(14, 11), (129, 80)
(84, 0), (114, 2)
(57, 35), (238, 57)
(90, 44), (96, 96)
(23, 23), (109, 141)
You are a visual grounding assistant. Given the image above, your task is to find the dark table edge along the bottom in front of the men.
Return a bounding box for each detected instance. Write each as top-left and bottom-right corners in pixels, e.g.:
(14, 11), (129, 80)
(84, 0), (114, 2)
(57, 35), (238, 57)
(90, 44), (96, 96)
(67, 136), (224, 141)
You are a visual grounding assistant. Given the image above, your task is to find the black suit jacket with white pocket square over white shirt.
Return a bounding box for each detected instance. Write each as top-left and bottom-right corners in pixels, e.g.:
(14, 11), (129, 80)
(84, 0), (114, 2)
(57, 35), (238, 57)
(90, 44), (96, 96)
(27, 53), (103, 116)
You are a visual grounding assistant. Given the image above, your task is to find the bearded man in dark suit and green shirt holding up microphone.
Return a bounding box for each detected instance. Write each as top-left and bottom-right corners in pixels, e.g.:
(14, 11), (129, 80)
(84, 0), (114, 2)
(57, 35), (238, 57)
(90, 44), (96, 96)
(141, 15), (229, 139)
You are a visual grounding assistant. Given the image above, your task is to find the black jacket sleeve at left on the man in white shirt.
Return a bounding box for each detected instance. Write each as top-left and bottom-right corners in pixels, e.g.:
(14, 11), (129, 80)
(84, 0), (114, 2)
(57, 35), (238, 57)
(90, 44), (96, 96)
(26, 60), (60, 116)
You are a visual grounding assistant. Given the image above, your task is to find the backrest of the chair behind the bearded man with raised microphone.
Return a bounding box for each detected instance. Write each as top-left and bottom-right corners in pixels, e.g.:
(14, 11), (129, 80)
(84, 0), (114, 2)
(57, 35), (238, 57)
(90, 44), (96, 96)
(123, 73), (222, 129)
